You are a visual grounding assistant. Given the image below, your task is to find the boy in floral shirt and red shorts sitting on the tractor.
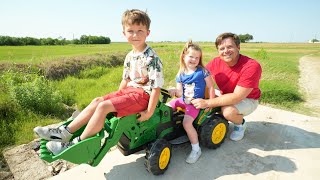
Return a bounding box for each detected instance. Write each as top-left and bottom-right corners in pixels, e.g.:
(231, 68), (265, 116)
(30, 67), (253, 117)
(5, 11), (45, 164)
(34, 9), (164, 155)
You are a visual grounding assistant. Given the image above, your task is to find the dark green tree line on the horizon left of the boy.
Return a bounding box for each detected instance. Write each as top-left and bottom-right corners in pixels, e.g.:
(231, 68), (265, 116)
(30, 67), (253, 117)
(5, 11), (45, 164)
(0, 35), (111, 46)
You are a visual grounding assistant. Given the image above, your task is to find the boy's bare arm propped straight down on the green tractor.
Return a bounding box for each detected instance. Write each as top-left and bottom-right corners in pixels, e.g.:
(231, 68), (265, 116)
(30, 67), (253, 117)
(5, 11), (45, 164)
(138, 88), (160, 121)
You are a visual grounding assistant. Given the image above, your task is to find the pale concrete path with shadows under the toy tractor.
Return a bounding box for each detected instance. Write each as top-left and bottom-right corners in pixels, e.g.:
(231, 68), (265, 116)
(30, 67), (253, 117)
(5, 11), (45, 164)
(51, 105), (320, 180)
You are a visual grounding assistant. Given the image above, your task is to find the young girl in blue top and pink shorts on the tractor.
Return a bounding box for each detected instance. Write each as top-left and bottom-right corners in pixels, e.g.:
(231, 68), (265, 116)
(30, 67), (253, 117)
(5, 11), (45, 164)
(168, 41), (215, 163)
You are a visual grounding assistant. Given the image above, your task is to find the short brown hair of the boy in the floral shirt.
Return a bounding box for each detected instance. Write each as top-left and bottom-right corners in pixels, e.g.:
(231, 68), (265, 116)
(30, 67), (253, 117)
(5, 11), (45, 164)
(122, 9), (151, 30)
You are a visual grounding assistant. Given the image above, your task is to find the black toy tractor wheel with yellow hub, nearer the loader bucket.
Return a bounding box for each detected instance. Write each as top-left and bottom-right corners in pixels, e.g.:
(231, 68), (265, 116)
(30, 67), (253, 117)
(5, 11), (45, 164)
(144, 139), (172, 175)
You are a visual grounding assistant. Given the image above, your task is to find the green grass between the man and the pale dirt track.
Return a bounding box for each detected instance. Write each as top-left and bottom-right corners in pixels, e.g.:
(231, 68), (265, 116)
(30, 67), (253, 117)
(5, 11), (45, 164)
(242, 44), (320, 114)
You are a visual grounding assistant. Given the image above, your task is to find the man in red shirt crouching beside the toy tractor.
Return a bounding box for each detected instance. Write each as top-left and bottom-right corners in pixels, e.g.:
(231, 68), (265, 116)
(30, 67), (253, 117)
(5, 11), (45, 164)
(191, 33), (262, 141)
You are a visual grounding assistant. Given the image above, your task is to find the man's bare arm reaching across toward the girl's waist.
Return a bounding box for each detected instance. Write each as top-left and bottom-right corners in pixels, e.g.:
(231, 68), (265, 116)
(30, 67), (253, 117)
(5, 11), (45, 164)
(191, 86), (253, 109)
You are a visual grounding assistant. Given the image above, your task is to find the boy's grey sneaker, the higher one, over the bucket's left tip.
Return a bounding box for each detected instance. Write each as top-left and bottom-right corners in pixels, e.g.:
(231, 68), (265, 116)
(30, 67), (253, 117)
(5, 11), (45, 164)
(33, 126), (72, 142)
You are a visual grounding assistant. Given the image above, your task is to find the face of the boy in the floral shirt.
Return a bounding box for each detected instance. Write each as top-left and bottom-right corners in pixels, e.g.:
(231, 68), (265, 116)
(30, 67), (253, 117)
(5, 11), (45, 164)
(123, 24), (150, 48)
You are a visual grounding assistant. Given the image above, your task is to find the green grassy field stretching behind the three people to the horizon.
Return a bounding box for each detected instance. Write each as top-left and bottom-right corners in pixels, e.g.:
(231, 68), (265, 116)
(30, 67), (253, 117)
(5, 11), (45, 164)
(0, 42), (320, 159)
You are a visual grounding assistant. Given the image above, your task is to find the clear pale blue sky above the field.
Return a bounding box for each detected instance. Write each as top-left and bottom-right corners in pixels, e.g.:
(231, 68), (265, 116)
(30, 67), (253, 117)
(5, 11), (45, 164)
(0, 0), (320, 42)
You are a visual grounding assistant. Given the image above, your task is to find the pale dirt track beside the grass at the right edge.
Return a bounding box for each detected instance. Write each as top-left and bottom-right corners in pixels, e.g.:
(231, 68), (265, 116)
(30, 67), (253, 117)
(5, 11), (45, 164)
(299, 55), (320, 117)
